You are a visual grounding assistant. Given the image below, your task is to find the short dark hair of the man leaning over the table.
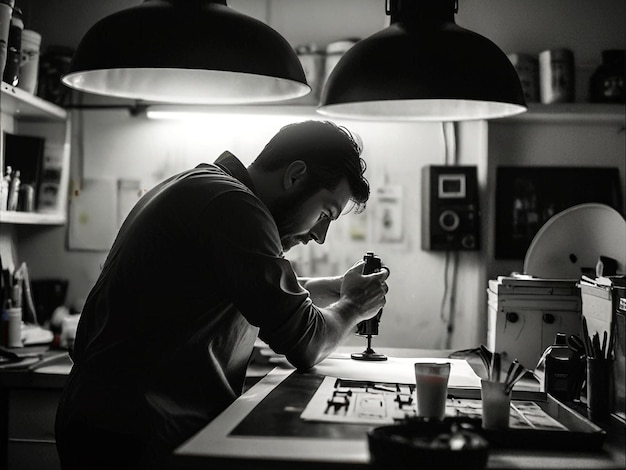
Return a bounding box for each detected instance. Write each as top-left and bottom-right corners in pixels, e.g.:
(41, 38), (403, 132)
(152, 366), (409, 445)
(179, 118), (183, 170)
(253, 121), (370, 212)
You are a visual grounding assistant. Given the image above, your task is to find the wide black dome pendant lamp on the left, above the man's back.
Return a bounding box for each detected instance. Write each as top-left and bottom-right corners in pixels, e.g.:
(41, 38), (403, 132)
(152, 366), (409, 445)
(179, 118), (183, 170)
(62, 0), (310, 104)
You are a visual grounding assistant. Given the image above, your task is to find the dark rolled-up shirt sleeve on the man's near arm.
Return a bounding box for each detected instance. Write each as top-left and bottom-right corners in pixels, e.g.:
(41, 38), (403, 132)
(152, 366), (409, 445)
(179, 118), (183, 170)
(199, 191), (325, 368)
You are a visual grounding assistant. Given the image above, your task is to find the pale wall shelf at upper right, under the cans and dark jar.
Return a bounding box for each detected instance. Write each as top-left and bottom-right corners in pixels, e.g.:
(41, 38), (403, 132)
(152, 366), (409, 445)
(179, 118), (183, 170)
(497, 103), (626, 126)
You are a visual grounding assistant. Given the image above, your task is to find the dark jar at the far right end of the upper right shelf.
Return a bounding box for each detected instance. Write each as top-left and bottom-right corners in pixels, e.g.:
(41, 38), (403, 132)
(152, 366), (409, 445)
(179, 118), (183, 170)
(589, 49), (626, 103)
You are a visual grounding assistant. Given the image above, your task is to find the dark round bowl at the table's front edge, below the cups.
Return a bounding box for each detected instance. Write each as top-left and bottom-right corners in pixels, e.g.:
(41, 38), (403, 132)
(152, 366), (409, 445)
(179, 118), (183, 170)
(367, 418), (489, 470)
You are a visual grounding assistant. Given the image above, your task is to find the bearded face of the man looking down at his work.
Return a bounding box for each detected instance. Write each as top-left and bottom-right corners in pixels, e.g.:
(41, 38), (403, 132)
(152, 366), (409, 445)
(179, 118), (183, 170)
(272, 180), (351, 251)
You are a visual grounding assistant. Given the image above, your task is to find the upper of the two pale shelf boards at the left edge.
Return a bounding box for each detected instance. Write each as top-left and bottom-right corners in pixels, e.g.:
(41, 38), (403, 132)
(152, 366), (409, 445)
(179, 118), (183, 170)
(1, 82), (67, 121)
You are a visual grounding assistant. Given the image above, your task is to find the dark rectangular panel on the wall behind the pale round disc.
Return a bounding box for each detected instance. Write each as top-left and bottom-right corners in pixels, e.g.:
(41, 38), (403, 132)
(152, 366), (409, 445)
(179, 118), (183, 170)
(495, 166), (623, 259)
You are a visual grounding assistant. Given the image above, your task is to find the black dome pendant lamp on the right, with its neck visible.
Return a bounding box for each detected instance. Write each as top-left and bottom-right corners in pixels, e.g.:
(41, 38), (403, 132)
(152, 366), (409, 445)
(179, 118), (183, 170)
(318, 0), (527, 121)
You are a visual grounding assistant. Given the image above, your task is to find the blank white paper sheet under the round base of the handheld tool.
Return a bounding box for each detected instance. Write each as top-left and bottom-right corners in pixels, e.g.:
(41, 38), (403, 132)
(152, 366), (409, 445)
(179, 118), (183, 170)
(312, 354), (480, 388)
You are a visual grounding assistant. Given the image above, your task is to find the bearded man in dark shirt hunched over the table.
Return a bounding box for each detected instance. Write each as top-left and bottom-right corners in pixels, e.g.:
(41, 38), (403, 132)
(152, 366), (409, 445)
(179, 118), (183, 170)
(56, 121), (388, 470)
